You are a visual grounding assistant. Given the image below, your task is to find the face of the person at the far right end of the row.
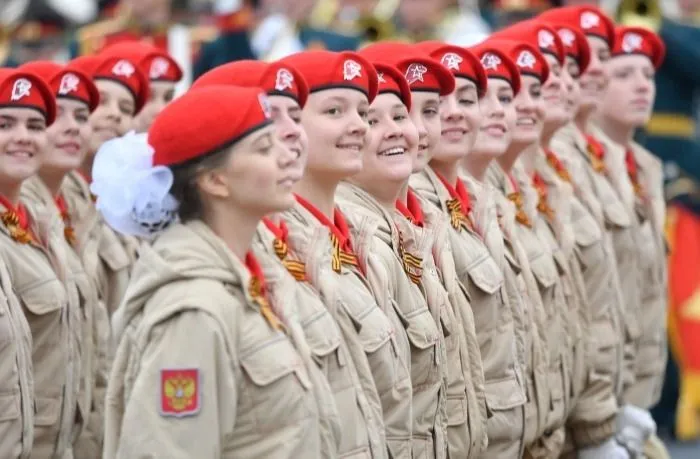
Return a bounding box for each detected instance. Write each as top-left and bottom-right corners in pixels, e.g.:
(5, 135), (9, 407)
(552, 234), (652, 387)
(600, 55), (656, 128)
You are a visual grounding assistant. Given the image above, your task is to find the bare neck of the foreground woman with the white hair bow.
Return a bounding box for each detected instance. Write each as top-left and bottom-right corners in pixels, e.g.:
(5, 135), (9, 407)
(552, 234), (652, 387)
(204, 209), (261, 260)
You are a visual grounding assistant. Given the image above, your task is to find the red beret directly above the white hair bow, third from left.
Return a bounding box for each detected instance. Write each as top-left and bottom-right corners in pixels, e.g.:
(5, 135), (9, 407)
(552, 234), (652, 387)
(68, 55), (149, 113)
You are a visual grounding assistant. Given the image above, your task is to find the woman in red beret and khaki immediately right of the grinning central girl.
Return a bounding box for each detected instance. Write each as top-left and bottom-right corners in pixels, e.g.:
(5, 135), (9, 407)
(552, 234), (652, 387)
(362, 43), (488, 458)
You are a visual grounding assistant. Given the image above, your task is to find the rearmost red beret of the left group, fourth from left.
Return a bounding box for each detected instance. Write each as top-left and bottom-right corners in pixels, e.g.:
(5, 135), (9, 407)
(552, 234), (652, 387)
(100, 41), (182, 83)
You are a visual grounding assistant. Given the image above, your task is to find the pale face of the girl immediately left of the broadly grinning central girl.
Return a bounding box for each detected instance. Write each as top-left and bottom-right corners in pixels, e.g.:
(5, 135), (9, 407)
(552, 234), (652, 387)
(301, 88), (369, 181)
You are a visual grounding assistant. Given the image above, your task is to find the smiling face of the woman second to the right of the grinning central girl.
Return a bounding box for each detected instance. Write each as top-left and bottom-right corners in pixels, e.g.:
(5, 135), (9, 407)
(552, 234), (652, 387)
(433, 77), (481, 163)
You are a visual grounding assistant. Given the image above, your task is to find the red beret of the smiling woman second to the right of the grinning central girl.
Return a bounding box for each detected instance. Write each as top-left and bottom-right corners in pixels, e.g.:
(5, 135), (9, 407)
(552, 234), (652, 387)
(415, 41), (488, 97)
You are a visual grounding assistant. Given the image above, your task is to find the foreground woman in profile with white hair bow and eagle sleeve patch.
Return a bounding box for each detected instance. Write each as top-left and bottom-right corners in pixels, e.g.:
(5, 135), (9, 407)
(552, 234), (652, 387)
(95, 86), (338, 458)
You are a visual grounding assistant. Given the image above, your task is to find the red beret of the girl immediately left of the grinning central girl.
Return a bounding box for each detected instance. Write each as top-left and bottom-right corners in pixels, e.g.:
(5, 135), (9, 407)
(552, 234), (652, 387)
(278, 50), (378, 103)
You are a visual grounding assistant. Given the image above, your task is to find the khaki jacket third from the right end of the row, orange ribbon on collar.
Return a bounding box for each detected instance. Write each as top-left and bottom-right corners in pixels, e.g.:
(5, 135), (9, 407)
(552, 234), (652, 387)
(537, 152), (617, 449)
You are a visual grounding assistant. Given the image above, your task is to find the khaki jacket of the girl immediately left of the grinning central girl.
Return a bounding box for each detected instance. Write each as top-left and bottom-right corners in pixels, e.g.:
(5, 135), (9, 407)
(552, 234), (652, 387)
(283, 203), (413, 458)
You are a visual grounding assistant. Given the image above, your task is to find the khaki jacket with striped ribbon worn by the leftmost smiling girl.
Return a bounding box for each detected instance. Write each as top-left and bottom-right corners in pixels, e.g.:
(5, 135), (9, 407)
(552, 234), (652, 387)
(0, 198), (81, 459)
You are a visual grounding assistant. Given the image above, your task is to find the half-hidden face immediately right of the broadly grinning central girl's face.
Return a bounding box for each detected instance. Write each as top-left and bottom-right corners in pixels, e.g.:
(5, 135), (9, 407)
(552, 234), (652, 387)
(409, 91), (440, 172)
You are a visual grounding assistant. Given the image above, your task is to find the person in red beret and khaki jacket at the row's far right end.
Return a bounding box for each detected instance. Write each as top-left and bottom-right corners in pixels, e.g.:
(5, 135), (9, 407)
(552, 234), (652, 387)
(597, 27), (667, 456)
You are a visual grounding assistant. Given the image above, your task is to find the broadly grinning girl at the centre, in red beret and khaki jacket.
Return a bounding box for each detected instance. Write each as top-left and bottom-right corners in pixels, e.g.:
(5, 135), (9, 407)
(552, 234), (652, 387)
(337, 62), (447, 458)
